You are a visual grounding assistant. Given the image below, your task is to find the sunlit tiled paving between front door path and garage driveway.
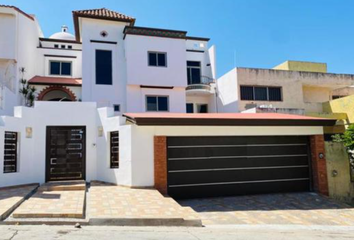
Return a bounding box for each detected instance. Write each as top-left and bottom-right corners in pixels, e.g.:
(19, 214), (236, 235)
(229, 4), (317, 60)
(87, 182), (199, 225)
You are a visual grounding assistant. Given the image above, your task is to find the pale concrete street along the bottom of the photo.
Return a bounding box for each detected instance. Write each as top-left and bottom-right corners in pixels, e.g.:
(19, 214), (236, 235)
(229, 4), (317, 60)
(0, 225), (354, 240)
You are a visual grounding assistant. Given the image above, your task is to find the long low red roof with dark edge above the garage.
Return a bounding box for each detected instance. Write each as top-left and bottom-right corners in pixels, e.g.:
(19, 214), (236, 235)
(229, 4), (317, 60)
(124, 113), (336, 126)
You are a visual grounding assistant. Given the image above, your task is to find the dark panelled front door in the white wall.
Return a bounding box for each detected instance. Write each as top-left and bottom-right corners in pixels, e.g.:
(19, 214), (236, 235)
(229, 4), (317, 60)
(46, 126), (86, 181)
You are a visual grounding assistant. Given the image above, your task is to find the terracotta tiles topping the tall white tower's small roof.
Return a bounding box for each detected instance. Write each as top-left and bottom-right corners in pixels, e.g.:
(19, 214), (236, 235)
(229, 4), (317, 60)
(73, 8), (135, 22)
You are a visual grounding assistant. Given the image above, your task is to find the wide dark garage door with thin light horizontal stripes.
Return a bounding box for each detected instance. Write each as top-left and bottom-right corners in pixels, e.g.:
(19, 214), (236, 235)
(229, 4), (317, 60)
(167, 136), (311, 198)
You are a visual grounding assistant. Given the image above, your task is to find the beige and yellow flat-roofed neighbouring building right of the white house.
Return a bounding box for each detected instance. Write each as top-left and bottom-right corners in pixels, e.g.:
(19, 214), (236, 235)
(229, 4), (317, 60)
(217, 61), (354, 115)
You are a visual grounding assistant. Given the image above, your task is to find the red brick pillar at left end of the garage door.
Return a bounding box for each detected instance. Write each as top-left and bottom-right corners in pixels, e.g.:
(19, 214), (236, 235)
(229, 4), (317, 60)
(154, 136), (167, 194)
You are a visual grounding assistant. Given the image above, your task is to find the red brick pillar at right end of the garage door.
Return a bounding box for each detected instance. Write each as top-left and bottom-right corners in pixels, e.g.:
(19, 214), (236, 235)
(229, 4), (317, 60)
(310, 135), (329, 196)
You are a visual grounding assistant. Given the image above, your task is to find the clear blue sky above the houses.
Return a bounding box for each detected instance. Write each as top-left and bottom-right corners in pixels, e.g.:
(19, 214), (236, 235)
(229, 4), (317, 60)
(1, 0), (354, 76)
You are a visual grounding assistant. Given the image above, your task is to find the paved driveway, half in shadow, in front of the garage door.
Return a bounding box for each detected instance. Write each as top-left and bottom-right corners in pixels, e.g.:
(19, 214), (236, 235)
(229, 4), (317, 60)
(179, 193), (354, 226)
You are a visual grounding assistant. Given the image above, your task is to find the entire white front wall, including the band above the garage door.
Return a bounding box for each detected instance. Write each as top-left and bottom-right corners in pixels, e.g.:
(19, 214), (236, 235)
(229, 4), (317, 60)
(0, 102), (323, 187)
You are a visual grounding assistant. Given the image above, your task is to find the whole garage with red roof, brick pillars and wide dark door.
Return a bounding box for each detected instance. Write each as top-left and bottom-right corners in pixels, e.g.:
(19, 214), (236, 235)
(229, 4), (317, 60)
(120, 113), (336, 199)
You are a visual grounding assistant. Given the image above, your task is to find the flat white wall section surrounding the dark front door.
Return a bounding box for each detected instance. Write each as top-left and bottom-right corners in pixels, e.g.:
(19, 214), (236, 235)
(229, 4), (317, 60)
(0, 102), (97, 187)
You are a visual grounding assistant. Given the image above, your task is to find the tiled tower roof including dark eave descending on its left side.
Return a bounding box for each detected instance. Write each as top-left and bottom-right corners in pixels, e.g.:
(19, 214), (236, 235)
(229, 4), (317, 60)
(73, 8), (135, 41)
